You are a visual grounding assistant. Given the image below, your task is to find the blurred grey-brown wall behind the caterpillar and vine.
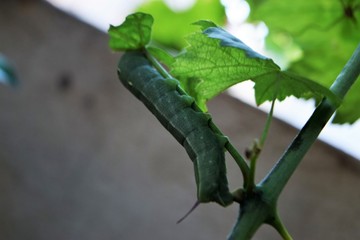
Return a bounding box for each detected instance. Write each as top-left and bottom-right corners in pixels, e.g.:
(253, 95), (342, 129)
(0, 1), (360, 240)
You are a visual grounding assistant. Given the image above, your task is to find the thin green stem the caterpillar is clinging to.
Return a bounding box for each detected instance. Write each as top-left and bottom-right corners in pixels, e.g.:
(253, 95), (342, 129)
(144, 49), (250, 186)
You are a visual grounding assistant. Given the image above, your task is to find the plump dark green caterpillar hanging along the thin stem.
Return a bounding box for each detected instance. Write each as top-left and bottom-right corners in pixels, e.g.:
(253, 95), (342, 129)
(118, 51), (233, 206)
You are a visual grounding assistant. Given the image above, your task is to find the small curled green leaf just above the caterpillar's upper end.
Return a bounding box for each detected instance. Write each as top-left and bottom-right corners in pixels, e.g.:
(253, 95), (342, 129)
(108, 12), (154, 51)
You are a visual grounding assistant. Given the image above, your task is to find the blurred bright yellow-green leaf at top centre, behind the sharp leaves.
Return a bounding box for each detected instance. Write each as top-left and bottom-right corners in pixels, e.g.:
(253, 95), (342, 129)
(138, 0), (226, 49)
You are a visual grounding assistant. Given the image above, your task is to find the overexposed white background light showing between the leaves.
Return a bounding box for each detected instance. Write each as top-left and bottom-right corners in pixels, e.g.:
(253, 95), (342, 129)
(48, 0), (360, 159)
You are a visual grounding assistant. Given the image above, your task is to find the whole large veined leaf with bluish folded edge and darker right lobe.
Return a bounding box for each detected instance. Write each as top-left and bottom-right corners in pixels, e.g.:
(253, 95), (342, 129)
(171, 25), (337, 110)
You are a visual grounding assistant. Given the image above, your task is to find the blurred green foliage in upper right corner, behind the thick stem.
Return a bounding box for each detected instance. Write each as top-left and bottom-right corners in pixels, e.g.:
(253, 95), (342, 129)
(248, 0), (360, 123)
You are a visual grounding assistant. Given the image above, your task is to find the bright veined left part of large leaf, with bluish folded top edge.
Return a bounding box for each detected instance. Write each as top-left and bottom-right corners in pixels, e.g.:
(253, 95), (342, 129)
(171, 27), (279, 110)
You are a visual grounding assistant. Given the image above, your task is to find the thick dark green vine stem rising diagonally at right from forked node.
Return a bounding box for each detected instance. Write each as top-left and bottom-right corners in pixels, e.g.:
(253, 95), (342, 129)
(228, 44), (360, 240)
